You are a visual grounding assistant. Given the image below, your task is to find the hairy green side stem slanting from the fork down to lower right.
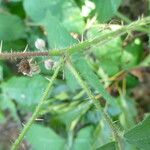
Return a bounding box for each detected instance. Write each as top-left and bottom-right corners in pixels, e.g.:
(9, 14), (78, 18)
(66, 62), (124, 150)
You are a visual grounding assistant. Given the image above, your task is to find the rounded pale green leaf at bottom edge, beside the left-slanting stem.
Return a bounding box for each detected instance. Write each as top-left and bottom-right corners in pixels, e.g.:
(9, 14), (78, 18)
(26, 124), (65, 150)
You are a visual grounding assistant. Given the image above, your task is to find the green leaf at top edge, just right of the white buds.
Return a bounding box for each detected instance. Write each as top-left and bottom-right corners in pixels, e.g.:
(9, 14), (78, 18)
(94, 0), (122, 22)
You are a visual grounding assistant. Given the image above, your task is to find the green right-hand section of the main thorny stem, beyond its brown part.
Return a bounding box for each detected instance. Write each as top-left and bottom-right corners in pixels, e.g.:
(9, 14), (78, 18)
(49, 17), (150, 56)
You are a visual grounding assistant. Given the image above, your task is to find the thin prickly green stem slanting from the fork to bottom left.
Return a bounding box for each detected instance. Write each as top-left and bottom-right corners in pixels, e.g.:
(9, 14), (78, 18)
(11, 61), (62, 150)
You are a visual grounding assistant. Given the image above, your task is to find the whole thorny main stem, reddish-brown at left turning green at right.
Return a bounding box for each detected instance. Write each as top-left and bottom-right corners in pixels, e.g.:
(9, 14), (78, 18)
(0, 17), (150, 59)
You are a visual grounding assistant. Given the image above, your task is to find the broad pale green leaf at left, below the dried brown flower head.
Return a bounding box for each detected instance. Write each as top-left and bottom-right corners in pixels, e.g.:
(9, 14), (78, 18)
(1, 75), (47, 106)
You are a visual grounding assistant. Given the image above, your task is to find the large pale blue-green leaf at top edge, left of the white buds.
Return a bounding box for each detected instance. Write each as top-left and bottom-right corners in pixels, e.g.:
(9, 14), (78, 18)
(23, 0), (85, 33)
